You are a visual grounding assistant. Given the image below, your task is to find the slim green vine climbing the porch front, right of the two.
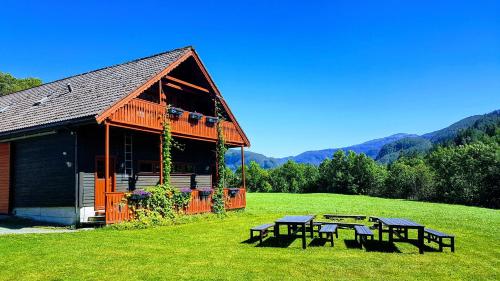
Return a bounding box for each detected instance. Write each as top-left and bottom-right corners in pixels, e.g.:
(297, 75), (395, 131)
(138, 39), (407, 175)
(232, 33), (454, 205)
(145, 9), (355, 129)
(212, 99), (227, 214)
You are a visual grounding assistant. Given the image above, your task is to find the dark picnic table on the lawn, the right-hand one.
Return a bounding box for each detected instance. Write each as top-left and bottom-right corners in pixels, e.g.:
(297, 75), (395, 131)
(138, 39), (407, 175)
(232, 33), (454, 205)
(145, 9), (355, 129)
(378, 218), (424, 254)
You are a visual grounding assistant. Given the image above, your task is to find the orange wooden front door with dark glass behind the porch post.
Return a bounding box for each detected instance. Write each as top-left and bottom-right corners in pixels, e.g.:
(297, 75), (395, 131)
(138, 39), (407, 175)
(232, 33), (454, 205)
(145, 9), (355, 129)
(94, 156), (116, 211)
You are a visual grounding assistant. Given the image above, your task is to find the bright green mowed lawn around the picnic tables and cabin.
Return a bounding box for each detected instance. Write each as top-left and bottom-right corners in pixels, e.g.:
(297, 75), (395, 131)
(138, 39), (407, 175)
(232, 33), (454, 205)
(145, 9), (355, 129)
(0, 194), (500, 280)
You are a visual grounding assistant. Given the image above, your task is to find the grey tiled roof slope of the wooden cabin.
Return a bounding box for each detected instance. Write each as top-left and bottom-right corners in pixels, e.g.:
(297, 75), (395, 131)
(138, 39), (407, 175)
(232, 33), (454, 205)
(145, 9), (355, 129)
(0, 47), (191, 134)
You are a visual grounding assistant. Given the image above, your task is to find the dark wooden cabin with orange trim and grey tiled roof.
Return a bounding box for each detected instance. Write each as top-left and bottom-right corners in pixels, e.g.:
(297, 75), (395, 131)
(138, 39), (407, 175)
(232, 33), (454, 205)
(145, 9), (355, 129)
(0, 47), (250, 224)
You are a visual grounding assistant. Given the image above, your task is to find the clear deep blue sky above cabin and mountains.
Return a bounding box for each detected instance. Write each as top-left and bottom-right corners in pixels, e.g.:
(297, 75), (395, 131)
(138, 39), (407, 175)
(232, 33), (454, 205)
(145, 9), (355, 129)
(0, 0), (500, 157)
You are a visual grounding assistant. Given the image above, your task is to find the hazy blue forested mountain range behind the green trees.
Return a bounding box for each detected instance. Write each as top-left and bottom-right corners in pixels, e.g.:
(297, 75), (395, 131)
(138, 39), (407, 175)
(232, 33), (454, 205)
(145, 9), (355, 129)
(226, 110), (500, 170)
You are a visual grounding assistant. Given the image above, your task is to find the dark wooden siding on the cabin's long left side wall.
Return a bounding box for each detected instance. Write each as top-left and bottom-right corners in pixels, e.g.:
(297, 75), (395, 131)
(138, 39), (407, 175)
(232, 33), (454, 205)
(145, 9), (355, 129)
(12, 132), (76, 207)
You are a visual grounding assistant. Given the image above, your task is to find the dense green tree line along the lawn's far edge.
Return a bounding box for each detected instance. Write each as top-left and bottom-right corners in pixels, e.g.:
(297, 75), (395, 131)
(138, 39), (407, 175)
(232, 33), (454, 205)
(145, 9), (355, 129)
(226, 121), (500, 208)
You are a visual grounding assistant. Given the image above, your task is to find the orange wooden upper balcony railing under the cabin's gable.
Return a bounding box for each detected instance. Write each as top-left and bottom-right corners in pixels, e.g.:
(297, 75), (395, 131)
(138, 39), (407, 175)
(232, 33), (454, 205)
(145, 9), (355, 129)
(110, 99), (243, 145)
